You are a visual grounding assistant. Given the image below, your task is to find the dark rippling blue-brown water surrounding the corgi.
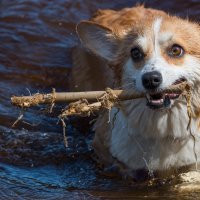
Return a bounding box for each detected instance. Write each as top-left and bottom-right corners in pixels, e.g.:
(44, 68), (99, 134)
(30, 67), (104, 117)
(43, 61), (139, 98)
(0, 0), (200, 199)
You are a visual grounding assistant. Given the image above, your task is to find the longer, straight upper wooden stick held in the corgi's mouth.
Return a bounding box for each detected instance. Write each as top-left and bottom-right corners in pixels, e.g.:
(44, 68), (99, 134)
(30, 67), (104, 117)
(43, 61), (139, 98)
(11, 82), (187, 108)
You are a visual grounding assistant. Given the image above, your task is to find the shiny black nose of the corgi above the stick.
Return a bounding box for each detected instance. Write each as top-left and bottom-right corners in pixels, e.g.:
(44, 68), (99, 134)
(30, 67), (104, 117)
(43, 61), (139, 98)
(142, 71), (162, 90)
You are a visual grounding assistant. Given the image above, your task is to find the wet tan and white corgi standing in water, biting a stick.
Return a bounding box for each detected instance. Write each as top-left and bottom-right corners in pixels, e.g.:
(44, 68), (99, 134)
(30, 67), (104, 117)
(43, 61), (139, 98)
(73, 6), (200, 178)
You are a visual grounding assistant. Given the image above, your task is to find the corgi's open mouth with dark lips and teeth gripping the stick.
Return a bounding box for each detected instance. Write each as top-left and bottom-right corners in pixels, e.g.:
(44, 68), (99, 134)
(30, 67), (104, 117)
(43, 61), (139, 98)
(146, 78), (186, 109)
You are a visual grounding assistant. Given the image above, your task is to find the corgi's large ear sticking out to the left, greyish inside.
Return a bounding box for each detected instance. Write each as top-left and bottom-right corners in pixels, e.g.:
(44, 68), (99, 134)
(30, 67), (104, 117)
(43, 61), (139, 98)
(76, 21), (118, 61)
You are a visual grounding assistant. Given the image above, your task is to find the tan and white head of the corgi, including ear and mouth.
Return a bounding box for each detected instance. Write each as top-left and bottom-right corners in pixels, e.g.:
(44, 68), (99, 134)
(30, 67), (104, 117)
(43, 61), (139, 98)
(77, 15), (200, 109)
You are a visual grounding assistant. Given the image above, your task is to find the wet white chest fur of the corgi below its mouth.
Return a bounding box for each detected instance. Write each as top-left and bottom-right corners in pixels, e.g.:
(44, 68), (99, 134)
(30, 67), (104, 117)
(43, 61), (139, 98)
(110, 99), (200, 170)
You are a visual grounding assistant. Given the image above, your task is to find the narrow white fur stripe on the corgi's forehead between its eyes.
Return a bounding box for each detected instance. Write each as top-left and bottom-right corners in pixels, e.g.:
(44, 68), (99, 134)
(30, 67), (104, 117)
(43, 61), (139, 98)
(153, 18), (162, 55)
